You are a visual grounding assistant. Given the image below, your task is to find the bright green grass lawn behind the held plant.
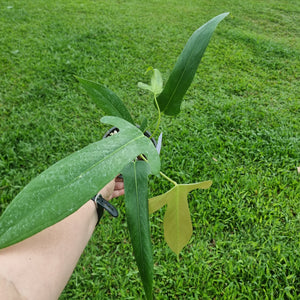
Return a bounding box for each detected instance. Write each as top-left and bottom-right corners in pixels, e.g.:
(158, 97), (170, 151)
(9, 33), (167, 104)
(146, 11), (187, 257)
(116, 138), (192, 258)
(0, 0), (300, 299)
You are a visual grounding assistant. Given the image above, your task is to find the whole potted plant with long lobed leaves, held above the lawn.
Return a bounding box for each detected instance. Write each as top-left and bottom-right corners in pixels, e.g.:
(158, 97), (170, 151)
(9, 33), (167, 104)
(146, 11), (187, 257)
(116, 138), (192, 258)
(0, 13), (228, 299)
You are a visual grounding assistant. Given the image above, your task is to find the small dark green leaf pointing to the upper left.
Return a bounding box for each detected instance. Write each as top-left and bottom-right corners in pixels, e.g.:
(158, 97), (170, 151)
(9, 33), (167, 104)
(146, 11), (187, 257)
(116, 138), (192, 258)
(76, 77), (134, 124)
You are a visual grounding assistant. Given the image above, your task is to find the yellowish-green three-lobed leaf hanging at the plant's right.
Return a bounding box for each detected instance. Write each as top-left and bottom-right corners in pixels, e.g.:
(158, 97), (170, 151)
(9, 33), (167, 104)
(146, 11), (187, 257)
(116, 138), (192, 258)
(149, 181), (212, 256)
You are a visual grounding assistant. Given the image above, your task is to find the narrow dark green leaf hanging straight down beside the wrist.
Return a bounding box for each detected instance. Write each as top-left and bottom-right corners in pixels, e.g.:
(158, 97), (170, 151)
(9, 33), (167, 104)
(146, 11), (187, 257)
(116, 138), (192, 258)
(122, 161), (153, 299)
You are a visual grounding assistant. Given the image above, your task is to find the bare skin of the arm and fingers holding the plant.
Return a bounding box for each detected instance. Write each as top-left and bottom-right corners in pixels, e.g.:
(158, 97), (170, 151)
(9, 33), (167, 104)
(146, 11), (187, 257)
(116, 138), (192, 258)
(0, 178), (124, 300)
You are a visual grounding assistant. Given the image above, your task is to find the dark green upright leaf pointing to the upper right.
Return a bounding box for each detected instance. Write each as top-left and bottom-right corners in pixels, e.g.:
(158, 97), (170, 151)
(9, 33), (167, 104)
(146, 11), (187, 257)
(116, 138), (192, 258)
(157, 13), (228, 115)
